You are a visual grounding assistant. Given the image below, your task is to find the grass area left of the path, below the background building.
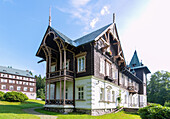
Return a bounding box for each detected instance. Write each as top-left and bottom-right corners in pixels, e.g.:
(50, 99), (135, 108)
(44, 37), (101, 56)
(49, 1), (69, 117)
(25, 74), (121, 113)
(0, 100), (44, 119)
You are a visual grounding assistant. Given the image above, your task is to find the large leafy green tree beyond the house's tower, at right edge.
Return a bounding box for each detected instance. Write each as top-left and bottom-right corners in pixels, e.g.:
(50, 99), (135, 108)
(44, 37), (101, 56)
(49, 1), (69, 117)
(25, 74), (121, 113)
(147, 71), (170, 105)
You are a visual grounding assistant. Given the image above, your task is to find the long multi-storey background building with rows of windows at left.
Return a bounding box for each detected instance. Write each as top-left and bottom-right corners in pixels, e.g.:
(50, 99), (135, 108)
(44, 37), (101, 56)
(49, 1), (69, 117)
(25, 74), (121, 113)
(0, 66), (36, 99)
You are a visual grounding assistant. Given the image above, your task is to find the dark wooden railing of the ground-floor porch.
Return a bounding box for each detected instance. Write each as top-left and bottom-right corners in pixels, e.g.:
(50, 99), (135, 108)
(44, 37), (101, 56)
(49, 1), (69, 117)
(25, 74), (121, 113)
(45, 99), (73, 105)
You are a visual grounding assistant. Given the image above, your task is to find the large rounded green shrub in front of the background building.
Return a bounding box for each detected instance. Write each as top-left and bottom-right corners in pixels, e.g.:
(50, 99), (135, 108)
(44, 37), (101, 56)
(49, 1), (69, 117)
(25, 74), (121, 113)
(4, 91), (28, 102)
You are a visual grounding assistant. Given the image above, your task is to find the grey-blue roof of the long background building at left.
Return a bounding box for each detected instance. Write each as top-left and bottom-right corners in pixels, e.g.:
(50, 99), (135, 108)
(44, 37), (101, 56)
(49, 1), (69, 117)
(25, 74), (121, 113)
(0, 66), (33, 77)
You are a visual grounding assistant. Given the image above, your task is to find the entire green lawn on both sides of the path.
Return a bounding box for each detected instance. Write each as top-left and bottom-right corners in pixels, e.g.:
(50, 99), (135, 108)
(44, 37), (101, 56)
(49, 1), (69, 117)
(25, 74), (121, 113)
(0, 100), (140, 119)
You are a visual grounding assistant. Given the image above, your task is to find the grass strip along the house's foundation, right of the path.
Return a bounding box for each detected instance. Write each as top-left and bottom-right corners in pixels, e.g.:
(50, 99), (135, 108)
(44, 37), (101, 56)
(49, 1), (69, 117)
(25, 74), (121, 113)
(35, 108), (141, 119)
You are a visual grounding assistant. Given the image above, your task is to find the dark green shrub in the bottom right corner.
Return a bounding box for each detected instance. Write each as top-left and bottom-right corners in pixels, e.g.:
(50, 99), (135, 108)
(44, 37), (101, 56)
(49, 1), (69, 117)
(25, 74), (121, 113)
(138, 104), (170, 119)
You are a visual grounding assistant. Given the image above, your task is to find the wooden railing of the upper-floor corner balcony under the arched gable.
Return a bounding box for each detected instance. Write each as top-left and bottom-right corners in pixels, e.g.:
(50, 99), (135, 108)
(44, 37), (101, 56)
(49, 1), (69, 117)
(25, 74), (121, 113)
(47, 70), (74, 78)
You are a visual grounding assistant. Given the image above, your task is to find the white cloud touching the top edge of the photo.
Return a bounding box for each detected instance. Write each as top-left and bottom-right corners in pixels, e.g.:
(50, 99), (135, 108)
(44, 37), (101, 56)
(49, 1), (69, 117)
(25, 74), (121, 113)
(71, 0), (90, 7)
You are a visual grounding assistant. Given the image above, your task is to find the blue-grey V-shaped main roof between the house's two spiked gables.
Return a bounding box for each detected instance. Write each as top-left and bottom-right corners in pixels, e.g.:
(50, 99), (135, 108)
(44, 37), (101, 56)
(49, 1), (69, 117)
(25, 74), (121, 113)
(50, 23), (112, 47)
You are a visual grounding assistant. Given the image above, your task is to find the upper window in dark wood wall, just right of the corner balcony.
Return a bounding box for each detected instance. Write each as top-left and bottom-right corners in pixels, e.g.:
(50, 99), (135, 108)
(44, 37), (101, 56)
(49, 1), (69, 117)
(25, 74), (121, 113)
(77, 56), (85, 72)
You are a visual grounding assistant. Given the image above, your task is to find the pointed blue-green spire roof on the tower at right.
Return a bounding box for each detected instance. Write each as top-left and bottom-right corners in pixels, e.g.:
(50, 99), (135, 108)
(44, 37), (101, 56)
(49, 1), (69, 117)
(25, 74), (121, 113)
(129, 50), (140, 67)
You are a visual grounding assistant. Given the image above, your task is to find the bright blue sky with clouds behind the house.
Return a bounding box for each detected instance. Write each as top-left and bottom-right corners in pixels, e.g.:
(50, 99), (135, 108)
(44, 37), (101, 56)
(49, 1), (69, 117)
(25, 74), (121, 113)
(0, 0), (170, 76)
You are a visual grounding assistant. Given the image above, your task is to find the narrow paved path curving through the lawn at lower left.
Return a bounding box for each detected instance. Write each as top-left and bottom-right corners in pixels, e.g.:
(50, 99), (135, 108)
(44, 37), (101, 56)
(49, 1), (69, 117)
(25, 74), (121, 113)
(23, 107), (57, 119)
